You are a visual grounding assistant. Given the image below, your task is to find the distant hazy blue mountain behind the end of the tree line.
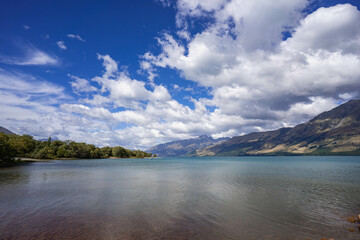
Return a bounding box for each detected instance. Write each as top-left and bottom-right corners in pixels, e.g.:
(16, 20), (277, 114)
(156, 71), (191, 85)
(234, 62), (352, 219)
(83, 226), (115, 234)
(147, 136), (228, 157)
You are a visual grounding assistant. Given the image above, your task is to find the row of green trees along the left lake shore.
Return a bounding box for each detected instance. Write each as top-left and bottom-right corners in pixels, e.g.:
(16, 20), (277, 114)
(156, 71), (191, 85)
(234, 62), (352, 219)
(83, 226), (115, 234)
(0, 133), (151, 162)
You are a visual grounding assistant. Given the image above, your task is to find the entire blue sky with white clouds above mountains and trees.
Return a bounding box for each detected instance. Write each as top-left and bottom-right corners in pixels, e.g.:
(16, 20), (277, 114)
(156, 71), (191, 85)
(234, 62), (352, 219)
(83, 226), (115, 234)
(0, 0), (360, 150)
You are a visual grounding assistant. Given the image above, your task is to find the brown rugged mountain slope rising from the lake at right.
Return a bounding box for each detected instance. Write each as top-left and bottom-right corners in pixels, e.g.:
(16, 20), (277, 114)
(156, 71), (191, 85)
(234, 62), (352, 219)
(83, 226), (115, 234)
(196, 100), (360, 156)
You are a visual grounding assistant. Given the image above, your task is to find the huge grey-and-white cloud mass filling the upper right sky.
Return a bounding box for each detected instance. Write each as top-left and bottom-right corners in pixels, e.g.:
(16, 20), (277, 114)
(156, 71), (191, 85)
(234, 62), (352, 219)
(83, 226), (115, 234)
(143, 0), (360, 129)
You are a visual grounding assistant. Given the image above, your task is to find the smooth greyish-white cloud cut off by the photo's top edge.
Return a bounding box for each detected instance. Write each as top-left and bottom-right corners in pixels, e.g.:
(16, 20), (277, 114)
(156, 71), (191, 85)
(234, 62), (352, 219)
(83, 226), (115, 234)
(216, 0), (308, 51)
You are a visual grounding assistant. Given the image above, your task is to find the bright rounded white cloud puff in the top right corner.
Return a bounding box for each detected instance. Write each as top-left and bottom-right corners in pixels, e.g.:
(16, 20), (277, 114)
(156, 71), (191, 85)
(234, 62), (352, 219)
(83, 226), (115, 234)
(284, 4), (360, 54)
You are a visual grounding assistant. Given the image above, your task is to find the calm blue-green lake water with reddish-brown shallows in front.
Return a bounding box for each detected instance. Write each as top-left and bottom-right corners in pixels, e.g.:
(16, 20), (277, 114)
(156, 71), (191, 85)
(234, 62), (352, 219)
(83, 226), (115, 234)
(0, 157), (360, 240)
